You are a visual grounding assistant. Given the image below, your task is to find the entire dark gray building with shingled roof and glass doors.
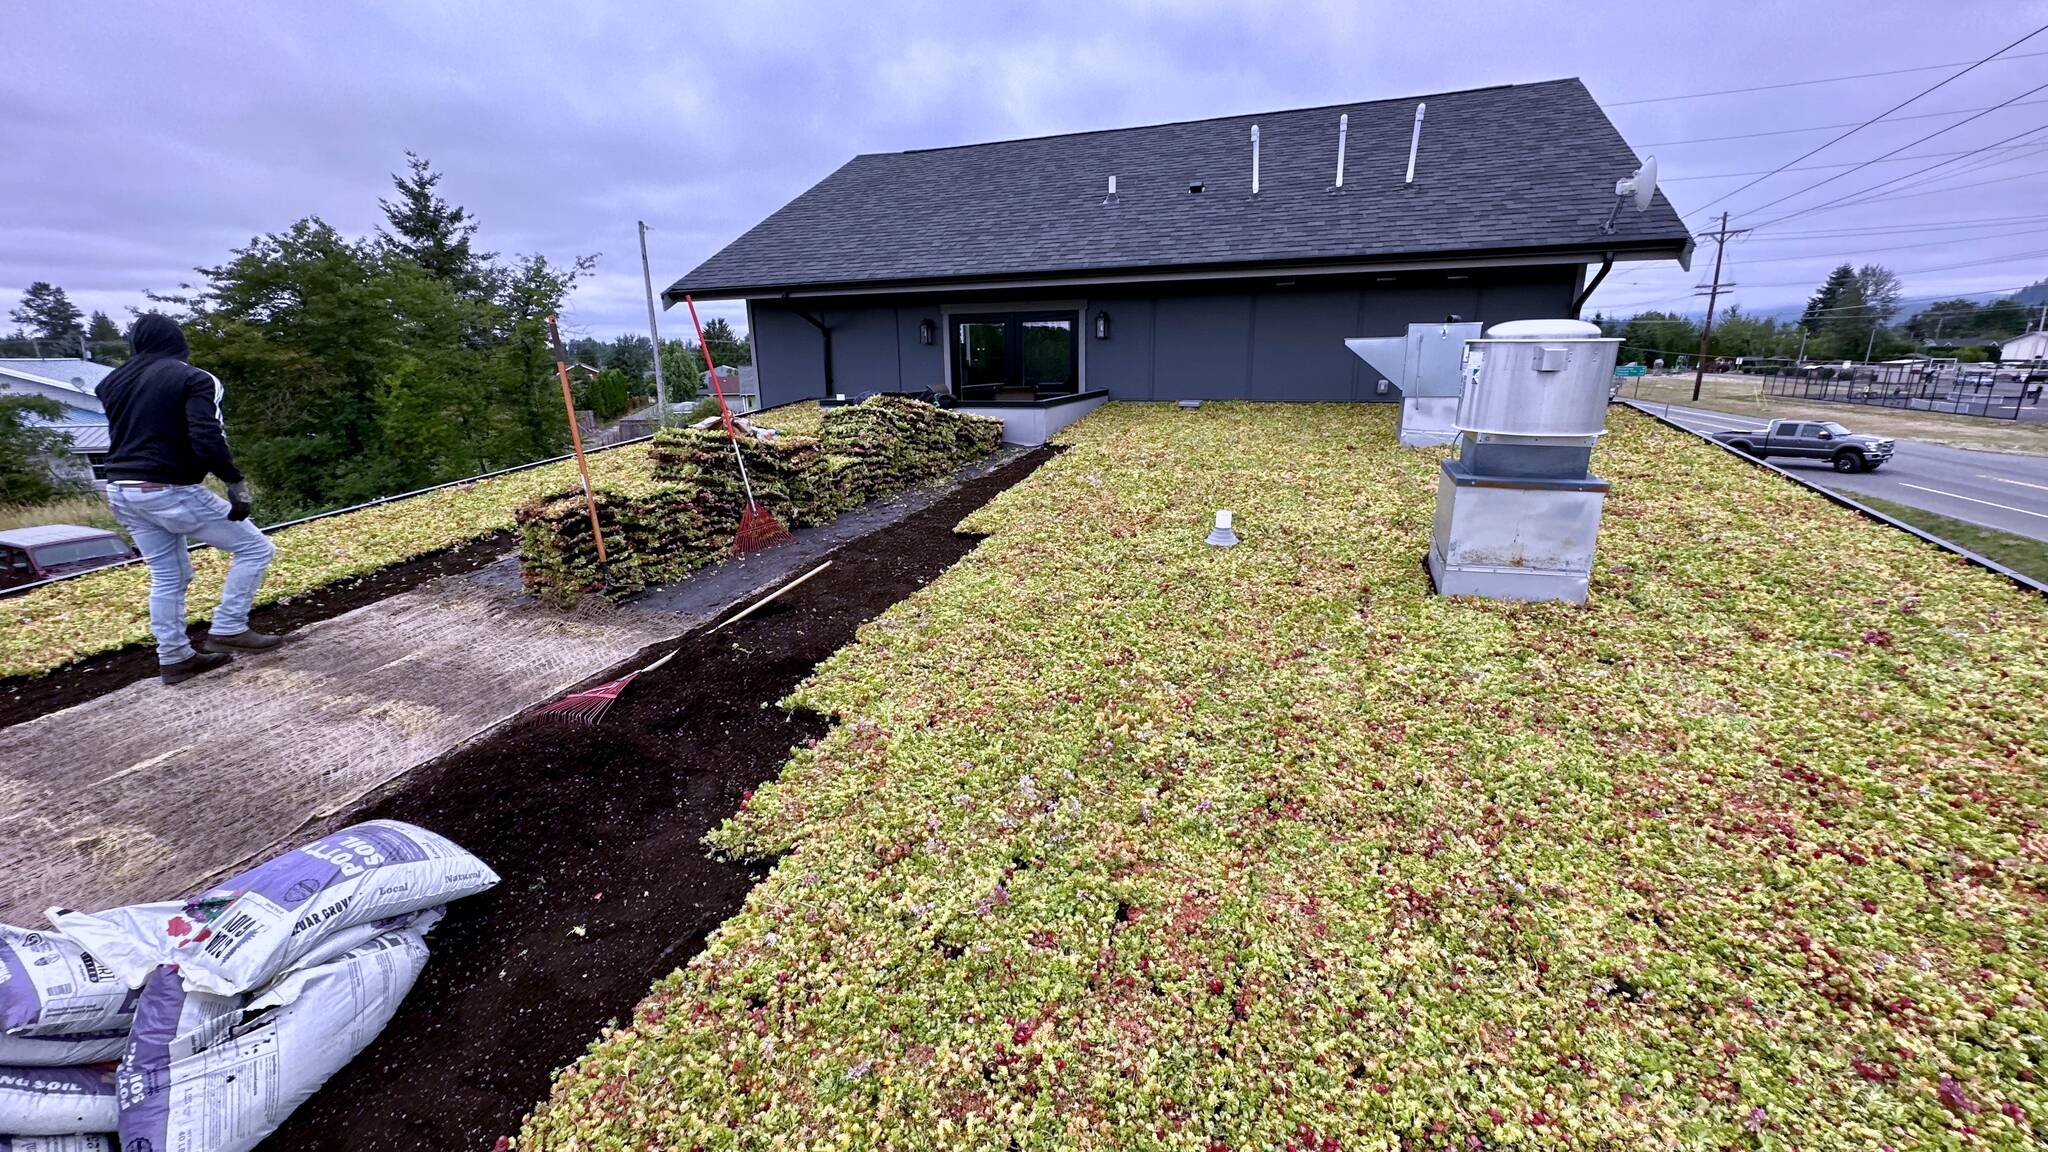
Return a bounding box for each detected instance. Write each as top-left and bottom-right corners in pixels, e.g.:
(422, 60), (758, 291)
(664, 80), (1692, 434)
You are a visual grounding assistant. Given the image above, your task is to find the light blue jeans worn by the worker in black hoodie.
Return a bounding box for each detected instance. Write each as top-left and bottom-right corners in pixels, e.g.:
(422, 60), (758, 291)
(106, 484), (276, 664)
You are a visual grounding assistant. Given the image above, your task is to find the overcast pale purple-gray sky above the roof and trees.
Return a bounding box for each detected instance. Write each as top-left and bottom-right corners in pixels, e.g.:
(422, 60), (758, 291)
(12, 0), (2048, 336)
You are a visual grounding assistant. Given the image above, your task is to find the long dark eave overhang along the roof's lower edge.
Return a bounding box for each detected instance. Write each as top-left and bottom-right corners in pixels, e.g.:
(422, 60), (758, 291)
(662, 236), (1694, 307)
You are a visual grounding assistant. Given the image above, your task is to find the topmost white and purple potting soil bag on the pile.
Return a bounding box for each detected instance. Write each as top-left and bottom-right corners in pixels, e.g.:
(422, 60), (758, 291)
(49, 820), (498, 996)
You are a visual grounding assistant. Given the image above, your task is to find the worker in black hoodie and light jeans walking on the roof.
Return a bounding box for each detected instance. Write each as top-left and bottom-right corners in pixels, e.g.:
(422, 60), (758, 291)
(94, 314), (281, 685)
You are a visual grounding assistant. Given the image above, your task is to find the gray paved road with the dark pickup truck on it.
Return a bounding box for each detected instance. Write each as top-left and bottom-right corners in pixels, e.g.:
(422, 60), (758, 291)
(1651, 406), (2048, 541)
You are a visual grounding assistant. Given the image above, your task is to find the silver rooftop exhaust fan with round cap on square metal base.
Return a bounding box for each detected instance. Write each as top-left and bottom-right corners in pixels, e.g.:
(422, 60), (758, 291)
(1430, 320), (1620, 603)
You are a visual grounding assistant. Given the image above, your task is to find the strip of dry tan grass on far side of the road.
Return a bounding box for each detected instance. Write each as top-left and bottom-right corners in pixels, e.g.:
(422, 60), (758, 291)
(1622, 375), (2048, 453)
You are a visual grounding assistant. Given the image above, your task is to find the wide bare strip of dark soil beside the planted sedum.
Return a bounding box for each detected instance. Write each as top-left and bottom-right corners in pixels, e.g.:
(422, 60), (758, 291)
(264, 449), (1049, 1152)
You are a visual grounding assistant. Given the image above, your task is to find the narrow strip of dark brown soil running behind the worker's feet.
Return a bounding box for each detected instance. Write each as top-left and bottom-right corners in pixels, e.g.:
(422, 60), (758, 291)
(0, 531), (514, 728)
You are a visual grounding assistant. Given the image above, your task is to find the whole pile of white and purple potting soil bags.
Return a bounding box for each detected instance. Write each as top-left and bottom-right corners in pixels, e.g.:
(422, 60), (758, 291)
(0, 820), (498, 1152)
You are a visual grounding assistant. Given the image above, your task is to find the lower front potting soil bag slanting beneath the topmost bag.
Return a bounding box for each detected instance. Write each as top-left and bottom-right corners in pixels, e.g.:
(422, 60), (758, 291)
(117, 929), (426, 1152)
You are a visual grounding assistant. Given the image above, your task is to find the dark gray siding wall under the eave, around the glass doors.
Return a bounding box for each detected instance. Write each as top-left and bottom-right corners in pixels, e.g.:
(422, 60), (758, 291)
(752, 264), (1579, 404)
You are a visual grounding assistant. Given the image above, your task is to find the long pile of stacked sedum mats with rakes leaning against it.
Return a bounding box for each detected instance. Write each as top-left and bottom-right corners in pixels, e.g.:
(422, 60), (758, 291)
(516, 396), (1004, 609)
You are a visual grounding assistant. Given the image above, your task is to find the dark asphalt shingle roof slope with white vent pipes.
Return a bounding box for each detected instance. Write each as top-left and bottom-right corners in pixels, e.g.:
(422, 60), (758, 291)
(664, 80), (1688, 299)
